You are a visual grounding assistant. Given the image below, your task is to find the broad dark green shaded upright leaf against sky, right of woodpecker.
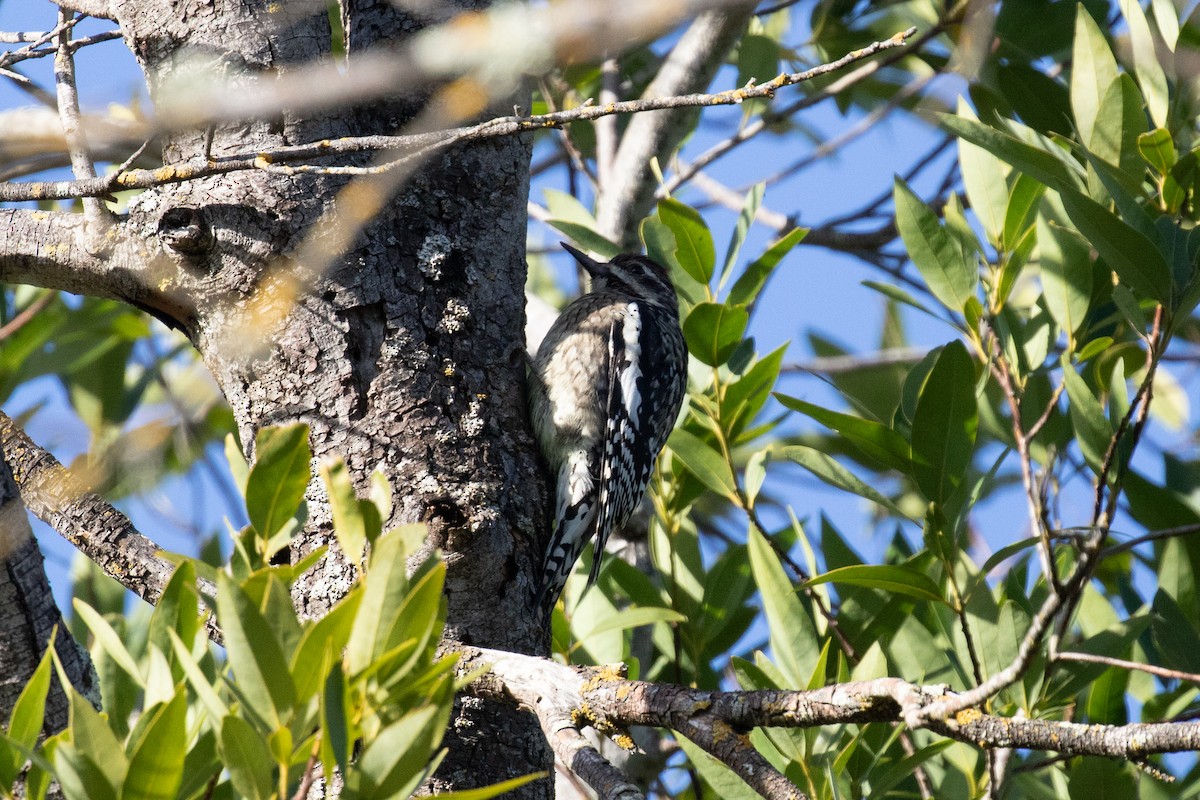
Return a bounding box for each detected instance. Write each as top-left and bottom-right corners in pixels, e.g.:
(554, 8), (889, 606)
(912, 341), (979, 503)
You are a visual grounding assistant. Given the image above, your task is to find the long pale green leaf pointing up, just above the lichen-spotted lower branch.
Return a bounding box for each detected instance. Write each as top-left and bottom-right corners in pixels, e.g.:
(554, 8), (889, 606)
(746, 528), (820, 688)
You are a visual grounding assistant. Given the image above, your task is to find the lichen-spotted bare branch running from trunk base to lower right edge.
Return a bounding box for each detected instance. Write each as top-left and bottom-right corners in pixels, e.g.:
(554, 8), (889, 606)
(460, 648), (1200, 798)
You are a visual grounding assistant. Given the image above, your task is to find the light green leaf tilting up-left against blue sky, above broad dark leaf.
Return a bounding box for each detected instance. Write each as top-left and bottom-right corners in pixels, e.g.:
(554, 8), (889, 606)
(893, 176), (979, 311)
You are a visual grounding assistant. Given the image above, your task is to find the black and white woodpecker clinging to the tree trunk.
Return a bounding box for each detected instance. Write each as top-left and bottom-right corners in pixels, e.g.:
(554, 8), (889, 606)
(530, 243), (688, 615)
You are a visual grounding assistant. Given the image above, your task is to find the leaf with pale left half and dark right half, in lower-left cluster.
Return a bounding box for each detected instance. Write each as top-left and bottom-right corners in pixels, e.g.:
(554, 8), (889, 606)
(217, 573), (295, 738)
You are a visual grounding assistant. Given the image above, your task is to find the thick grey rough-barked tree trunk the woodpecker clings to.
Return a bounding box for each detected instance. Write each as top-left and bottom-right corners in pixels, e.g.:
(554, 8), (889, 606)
(0, 0), (551, 798)
